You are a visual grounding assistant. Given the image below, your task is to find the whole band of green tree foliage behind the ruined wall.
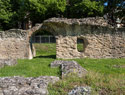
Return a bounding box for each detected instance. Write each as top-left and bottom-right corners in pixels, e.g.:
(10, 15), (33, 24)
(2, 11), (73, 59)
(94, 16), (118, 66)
(0, 0), (124, 30)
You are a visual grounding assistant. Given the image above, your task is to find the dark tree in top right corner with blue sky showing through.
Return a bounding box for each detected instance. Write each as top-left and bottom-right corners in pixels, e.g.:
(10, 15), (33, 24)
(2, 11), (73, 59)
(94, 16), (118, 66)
(105, 0), (125, 25)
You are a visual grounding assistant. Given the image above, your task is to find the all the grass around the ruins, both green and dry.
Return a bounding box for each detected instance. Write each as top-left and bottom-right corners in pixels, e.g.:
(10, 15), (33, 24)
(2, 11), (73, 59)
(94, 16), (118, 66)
(0, 44), (125, 95)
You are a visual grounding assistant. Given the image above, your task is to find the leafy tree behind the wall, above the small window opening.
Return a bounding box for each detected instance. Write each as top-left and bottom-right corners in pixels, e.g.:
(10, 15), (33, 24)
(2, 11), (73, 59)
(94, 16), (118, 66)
(67, 0), (104, 18)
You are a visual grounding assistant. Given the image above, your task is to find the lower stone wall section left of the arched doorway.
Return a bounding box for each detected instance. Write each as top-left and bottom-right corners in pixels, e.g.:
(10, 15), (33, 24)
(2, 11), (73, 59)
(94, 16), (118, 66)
(0, 24), (42, 59)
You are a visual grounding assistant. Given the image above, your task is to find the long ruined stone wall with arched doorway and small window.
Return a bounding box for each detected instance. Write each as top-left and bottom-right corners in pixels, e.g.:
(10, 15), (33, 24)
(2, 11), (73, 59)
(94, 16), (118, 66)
(0, 18), (125, 59)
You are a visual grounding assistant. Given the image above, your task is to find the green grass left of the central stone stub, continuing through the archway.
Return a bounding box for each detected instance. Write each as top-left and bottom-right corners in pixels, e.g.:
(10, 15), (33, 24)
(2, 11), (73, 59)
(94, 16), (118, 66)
(0, 44), (60, 77)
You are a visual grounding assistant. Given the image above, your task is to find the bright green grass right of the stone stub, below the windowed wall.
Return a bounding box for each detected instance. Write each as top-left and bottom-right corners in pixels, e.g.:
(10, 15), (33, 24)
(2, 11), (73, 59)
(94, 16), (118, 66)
(74, 58), (125, 74)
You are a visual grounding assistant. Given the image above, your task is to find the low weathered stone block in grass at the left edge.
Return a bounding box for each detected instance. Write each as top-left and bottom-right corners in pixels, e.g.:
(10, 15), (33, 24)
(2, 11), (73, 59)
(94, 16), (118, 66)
(0, 59), (17, 68)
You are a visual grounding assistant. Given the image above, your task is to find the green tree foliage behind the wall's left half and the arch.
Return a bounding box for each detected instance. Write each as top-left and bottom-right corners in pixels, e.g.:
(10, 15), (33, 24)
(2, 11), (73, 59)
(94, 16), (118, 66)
(0, 0), (66, 30)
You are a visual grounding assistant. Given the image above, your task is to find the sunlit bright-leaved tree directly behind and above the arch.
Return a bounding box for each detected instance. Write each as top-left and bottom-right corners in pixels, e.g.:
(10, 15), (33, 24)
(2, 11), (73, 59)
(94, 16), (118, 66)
(29, 0), (66, 23)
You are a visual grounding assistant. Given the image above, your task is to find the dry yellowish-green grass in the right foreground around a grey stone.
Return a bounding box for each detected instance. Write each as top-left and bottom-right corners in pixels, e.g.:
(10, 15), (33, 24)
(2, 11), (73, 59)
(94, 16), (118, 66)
(48, 71), (125, 95)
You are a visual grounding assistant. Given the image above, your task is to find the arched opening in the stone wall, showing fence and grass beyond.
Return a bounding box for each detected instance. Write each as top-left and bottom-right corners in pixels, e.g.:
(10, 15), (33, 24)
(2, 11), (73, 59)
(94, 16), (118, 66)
(29, 29), (56, 59)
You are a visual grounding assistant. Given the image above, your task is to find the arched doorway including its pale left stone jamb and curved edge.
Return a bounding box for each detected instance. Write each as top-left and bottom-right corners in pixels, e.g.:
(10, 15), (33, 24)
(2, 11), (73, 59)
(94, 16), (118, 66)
(28, 24), (56, 59)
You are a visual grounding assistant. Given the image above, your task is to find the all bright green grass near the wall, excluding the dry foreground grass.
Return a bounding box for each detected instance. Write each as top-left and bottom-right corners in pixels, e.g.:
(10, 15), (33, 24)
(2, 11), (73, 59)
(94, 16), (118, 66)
(0, 44), (125, 77)
